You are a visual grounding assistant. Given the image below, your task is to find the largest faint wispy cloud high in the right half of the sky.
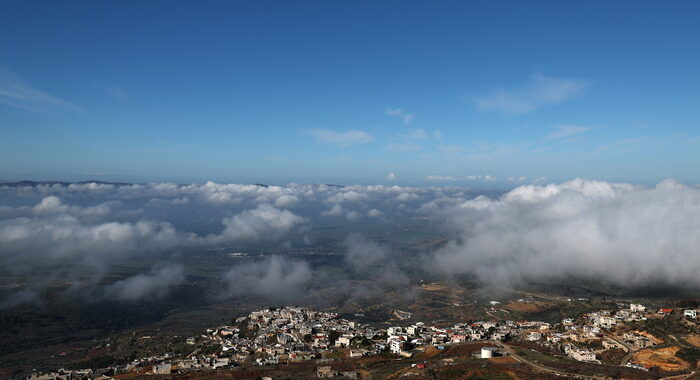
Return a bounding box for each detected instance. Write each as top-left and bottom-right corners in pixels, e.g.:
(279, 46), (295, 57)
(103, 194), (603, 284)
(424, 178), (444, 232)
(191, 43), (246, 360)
(474, 75), (588, 114)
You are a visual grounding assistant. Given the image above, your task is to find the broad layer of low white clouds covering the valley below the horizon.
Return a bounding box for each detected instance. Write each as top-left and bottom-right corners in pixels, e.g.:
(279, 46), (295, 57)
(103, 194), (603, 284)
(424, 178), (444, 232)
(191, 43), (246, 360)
(0, 176), (700, 306)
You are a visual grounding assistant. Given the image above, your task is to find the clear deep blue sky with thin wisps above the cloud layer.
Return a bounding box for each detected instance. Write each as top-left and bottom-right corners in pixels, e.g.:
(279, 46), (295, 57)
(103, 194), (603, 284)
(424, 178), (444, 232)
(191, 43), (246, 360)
(0, 1), (700, 187)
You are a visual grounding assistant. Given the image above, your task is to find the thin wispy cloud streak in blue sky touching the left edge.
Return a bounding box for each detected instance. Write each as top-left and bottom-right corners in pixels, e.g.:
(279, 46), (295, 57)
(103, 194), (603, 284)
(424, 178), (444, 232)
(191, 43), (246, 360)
(0, 65), (85, 113)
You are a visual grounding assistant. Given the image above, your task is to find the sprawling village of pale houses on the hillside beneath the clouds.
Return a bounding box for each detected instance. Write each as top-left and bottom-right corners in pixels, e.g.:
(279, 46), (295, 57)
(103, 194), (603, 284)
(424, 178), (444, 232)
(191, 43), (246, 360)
(28, 301), (700, 380)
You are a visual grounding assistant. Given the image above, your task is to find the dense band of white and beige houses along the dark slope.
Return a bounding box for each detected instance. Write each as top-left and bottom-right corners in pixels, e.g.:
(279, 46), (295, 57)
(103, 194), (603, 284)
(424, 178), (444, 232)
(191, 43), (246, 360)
(23, 303), (697, 380)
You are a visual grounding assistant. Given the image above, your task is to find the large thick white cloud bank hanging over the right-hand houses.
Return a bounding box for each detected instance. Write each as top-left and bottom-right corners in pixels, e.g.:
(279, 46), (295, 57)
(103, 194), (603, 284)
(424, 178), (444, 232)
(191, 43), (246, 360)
(433, 180), (700, 287)
